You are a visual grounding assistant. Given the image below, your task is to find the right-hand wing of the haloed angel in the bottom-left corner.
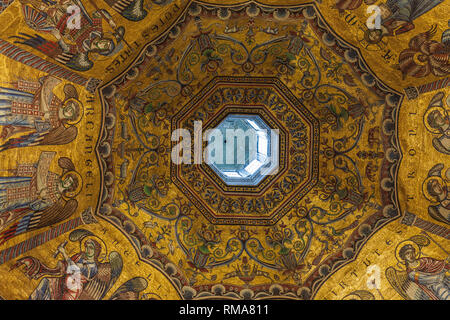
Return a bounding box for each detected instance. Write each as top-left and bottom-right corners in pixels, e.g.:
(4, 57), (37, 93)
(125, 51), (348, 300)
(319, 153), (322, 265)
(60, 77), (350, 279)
(79, 251), (123, 300)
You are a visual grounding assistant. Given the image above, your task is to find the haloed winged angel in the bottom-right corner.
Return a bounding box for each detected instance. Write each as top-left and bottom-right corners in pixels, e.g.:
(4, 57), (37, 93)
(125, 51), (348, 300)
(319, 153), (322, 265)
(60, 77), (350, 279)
(386, 235), (450, 300)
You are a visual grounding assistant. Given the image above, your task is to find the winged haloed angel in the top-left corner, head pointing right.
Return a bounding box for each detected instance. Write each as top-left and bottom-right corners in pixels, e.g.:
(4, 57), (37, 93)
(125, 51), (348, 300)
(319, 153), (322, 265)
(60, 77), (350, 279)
(12, 0), (125, 71)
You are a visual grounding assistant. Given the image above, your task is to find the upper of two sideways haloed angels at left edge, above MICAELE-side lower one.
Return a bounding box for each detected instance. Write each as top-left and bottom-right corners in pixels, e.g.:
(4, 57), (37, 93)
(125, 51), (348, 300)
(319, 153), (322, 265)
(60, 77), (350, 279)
(0, 76), (83, 151)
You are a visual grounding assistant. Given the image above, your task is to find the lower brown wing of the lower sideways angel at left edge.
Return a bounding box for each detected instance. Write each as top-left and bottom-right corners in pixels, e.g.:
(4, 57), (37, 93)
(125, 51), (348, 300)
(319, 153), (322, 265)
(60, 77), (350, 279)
(0, 199), (78, 244)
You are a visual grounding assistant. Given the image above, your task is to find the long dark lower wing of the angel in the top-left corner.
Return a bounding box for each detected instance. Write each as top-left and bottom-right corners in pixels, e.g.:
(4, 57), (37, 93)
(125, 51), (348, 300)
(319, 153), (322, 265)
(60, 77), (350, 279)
(11, 32), (94, 71)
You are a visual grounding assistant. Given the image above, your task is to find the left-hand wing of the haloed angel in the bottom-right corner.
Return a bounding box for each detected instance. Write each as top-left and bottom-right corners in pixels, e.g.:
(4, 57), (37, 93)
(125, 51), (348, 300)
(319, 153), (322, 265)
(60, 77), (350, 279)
(386, 267), (430, 300)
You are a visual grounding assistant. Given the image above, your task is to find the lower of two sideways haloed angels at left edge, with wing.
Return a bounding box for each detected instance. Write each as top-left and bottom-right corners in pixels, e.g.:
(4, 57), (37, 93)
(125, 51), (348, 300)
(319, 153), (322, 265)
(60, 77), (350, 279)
(0, 152), (82, 244)
